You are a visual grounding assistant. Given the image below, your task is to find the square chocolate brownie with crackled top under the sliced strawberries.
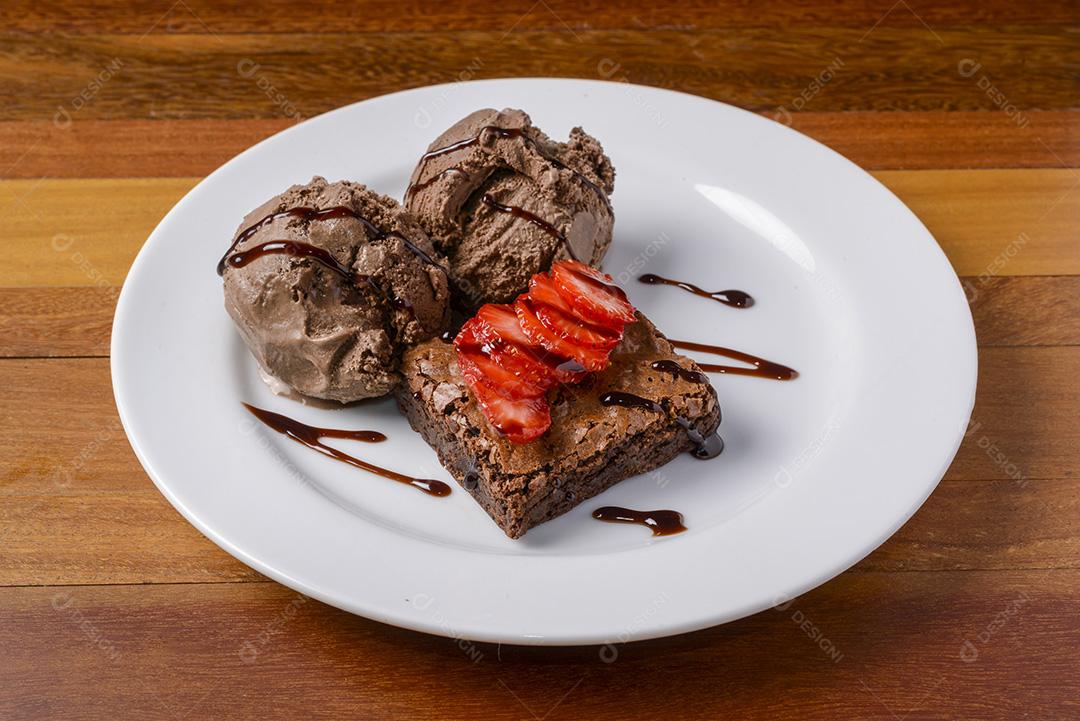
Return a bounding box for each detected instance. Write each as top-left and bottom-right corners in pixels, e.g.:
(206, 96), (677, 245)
(396, 313), (720, 539)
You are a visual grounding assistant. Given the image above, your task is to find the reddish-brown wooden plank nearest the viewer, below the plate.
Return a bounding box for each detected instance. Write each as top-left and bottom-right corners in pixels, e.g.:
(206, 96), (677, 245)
(0, 570), (1080, 721)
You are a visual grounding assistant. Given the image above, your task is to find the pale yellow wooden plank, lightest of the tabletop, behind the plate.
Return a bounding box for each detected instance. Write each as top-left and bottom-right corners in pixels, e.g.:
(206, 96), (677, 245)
(0, 169), (1080, 286)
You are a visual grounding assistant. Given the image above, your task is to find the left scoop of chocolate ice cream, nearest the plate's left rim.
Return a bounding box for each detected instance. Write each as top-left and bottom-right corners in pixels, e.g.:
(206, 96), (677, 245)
(221, 177), (449, 403)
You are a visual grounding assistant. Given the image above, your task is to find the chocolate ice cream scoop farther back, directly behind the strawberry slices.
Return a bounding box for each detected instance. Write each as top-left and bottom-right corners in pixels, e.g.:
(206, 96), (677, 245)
(405, 109), (615, 308)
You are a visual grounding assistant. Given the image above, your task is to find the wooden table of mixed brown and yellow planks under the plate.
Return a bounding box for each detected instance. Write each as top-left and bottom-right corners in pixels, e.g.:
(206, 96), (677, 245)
(0, 0), (1080, 720)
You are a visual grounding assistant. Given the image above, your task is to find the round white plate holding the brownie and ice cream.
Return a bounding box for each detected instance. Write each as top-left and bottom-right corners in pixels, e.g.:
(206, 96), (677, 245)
(112, 79), (976, 644)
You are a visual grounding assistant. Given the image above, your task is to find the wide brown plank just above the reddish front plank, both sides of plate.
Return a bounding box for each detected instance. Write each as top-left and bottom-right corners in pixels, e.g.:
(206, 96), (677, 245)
(0, 348), (1080, 584)
